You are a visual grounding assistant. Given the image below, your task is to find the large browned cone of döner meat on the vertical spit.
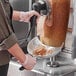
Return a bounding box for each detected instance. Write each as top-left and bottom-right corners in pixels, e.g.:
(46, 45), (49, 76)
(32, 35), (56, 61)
(40, 0), (70, 47)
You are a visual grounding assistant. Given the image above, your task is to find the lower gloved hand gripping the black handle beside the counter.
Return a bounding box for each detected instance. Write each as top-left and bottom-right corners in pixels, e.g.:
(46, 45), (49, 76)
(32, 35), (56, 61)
(21, 54), (36, 70)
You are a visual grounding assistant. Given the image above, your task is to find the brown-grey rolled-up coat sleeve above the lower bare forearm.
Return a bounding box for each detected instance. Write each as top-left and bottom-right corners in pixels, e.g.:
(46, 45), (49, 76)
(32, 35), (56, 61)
(0, 2), (17, 50)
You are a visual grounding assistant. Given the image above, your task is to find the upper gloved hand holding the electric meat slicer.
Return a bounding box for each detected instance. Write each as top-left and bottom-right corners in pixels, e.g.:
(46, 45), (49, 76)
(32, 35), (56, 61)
(20, 10), (40, 22)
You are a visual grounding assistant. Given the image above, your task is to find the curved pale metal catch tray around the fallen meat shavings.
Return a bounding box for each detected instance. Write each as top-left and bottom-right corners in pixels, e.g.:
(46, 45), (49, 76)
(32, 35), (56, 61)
(27, 36), (63, 58)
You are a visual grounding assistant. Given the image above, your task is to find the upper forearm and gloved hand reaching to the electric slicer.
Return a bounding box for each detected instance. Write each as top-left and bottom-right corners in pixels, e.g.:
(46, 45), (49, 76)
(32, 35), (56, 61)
(12, 10), (40, 22)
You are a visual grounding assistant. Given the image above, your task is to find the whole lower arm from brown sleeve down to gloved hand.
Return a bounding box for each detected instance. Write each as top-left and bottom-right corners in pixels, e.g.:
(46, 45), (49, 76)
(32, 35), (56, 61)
(0, 2), (36, 70)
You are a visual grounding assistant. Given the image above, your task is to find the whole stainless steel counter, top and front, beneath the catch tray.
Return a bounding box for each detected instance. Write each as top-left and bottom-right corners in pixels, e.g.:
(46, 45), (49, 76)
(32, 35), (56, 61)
(8, 57), (76, 76)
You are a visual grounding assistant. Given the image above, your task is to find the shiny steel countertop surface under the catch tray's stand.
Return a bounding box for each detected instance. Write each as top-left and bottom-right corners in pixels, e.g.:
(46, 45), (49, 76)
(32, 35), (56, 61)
(10, 57), (76, 76)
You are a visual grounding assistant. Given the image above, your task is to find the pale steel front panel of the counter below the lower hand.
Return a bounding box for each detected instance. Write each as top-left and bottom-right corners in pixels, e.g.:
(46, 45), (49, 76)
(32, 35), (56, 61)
(7, 61), (43, 76)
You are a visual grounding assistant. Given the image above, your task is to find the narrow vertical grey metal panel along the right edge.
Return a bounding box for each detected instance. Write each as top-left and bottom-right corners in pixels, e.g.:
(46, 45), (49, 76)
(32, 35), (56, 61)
(72, 0), (76, 59)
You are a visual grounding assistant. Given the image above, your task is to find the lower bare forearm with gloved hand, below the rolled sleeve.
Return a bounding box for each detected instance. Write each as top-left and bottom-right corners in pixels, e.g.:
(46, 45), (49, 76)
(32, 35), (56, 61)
(8, 43), (36, 70)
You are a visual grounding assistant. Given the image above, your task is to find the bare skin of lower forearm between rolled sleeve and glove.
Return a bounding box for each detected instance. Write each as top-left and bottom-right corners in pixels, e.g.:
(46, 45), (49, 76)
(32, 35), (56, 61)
(8, 43), (26, 63)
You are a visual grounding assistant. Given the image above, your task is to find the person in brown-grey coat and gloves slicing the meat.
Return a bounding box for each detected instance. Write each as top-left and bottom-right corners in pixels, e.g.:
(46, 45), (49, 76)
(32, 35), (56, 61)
(0, 0), (40, 76)
